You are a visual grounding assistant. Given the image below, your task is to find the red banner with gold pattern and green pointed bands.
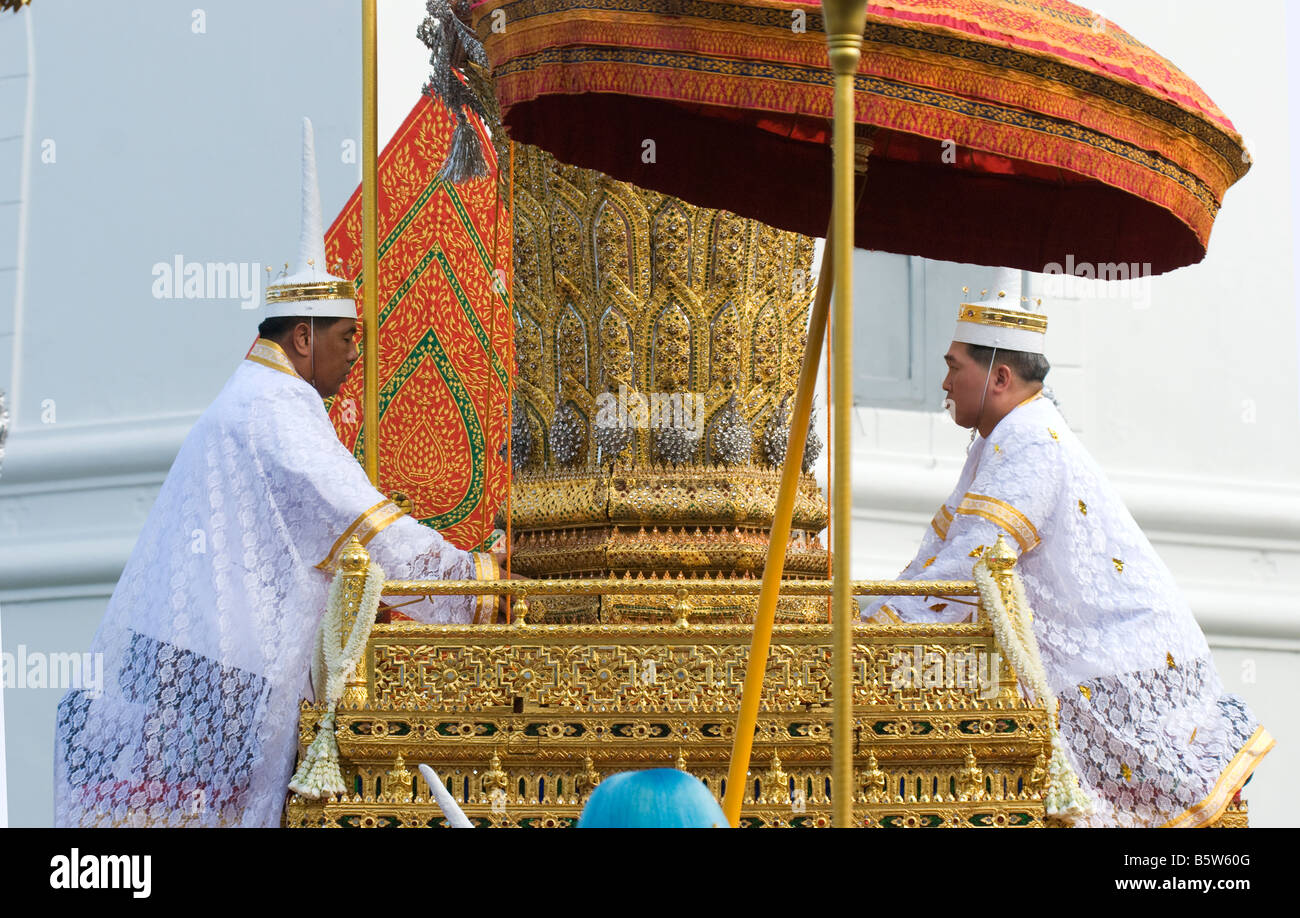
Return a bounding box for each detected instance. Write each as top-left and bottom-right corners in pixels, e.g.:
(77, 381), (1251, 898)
(325, 96), (514, 549)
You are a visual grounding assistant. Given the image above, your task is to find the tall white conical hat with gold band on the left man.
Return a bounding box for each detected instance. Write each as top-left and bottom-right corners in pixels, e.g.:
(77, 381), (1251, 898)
(265, 118), (356, 319)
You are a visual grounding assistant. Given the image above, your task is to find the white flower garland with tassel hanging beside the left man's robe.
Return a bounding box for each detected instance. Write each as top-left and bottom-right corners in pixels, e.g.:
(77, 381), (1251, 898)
(289, 563), (384, 800)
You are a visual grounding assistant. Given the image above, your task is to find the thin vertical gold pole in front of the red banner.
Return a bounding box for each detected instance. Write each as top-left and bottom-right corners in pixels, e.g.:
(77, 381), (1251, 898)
(361, 0), (380, 488)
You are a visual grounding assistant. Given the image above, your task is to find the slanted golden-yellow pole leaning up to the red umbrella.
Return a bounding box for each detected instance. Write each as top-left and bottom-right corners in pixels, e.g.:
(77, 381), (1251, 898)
(723, 230), (835, 828)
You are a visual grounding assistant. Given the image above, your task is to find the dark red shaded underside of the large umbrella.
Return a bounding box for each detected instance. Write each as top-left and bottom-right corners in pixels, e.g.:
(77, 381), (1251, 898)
(506, 92), (1205, 274)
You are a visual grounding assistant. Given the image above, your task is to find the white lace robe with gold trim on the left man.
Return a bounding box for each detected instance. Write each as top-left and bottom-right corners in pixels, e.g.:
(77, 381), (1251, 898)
(55, 341), (497, 826)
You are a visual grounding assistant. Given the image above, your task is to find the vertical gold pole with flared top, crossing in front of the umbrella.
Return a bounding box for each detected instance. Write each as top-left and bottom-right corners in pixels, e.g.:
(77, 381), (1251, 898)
(822, 0), (867, 828)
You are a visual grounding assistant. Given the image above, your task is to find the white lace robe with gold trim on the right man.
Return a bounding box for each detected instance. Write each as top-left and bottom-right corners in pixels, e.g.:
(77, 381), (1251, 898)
(862, 397), (1273, 826)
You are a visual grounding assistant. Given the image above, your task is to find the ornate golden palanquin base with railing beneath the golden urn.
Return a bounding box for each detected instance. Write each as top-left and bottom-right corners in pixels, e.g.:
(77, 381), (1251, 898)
(286, 551), (1048, 827)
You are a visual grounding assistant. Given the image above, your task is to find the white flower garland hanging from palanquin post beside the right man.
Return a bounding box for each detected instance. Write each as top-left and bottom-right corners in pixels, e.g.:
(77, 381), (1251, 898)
(974, 558), (1092, 820)
